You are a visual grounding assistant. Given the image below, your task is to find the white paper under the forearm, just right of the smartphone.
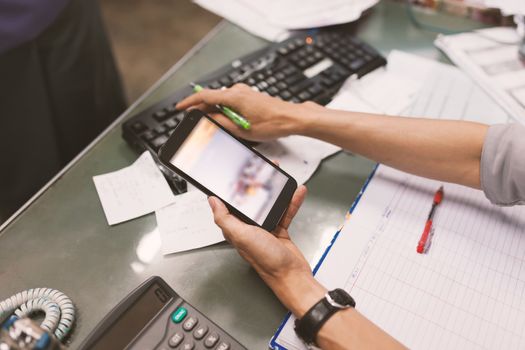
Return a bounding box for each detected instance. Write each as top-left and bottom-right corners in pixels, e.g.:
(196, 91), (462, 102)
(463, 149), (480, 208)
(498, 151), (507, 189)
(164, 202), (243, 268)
(256, 135), (341, 184)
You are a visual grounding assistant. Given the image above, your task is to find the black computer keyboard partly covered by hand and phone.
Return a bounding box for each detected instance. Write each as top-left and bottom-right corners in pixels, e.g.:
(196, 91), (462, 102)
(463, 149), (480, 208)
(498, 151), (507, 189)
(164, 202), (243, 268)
(122, 31), (386, 193)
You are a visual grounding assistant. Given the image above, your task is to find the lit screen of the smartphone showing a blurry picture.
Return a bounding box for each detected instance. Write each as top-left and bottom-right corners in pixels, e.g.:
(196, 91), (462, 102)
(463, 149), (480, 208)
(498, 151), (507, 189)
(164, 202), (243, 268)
(170, 118), (288, 225)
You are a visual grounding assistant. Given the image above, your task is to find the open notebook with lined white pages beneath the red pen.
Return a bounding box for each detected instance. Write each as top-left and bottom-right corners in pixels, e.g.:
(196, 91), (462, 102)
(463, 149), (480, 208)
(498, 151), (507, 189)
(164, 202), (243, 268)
(271, 166), (525, 349)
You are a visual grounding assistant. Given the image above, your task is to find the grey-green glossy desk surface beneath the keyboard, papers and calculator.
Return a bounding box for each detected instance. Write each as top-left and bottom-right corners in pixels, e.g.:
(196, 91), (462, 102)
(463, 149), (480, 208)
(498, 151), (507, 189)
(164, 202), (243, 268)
(0, 2), (484, 349)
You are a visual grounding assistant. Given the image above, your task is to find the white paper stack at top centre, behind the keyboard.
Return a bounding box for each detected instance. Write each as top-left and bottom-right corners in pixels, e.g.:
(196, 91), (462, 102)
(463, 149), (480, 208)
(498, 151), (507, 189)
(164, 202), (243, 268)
(194, 0), (379, 41)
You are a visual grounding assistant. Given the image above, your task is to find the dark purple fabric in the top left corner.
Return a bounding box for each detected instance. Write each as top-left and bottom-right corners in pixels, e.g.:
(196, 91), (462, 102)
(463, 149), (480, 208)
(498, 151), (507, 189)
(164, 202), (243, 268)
(0, 0), (69, 53)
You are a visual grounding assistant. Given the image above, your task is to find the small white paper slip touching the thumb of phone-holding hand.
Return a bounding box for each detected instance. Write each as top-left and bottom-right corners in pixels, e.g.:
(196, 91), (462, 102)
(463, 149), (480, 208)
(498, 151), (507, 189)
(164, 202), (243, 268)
(155, 191), (224, 255)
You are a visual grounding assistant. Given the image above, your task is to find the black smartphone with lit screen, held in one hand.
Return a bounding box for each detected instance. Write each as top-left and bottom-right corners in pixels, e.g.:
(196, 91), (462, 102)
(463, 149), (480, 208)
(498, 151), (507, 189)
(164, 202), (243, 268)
(159, 109), (297, 231)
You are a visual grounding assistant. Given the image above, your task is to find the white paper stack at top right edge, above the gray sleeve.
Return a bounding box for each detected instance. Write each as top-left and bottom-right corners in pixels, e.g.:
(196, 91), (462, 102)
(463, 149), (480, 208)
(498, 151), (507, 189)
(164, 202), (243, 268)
(435, 28), (525, 123)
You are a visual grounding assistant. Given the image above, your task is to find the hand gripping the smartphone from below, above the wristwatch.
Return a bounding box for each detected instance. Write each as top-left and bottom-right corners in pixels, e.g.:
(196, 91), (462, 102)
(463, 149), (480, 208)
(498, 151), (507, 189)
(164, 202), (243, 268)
(208, 186), (326, 317)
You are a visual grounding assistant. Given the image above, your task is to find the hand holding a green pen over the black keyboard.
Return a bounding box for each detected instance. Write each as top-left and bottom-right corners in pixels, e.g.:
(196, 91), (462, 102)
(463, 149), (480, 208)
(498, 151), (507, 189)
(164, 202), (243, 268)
(176, 84), (323, 141)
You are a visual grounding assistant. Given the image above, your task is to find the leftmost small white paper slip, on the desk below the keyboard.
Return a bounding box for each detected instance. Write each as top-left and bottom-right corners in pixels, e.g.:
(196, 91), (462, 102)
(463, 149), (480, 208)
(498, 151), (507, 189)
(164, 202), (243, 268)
(93, 152), (175, 225)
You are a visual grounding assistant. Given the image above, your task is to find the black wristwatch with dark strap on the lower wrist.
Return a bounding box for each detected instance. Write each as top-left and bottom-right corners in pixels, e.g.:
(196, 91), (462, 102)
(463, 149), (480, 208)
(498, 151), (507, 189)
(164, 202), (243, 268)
(294, 288), (355, 346)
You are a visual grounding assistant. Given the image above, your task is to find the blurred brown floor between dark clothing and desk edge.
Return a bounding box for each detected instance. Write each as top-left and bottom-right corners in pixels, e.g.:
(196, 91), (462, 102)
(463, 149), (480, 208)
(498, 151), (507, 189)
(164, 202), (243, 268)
(99, 0), (221, 103)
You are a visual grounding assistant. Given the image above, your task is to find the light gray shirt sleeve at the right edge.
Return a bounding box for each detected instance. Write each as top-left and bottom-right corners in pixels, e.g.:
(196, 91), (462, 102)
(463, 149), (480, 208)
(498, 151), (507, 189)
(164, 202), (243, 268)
(480, 124), (525, 205)
